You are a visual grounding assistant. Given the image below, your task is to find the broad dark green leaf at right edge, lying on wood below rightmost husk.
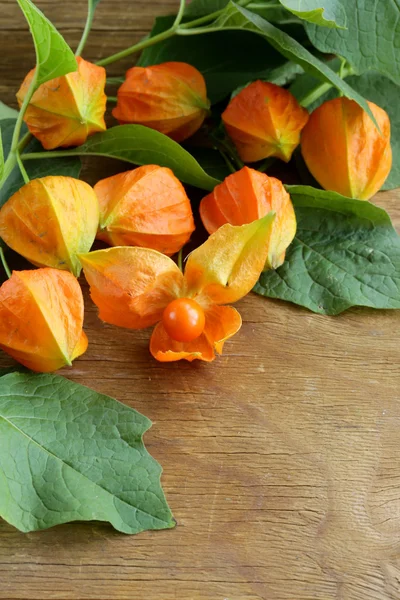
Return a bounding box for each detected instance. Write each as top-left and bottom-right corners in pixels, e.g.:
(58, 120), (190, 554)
(254, 186), (400, 315)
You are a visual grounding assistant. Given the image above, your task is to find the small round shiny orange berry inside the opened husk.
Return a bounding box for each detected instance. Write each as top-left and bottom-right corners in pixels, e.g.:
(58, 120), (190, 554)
(162, 298), (206, 342)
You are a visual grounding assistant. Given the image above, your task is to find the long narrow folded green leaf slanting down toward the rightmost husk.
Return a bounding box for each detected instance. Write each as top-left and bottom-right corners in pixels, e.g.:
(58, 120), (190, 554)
(211, 2), (376, 123)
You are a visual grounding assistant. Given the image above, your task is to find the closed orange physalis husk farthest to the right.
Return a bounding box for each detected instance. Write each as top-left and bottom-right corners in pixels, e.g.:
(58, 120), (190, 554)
(301, 97), (392, 200)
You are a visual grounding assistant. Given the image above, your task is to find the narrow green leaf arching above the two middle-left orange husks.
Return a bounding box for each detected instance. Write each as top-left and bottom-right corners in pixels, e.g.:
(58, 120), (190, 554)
(25, 125), (219, 190)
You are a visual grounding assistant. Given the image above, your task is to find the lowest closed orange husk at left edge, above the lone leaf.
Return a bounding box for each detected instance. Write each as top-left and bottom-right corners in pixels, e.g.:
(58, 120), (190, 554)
(0, 269), (88, 373)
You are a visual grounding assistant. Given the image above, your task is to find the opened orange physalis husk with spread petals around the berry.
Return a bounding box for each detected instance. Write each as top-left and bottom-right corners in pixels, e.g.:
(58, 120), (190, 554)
(80, 218), (274, 362)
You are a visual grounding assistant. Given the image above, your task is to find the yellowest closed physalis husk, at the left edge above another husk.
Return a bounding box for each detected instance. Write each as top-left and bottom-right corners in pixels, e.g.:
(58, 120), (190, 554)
(0, 175), (99, 276)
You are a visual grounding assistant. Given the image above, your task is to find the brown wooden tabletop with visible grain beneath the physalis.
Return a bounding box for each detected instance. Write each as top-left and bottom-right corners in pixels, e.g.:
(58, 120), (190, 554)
(0, 0), (400, 600)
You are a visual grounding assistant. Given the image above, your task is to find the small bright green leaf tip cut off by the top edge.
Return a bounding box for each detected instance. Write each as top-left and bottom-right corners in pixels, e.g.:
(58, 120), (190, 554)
(279, 0), (346, 29)
